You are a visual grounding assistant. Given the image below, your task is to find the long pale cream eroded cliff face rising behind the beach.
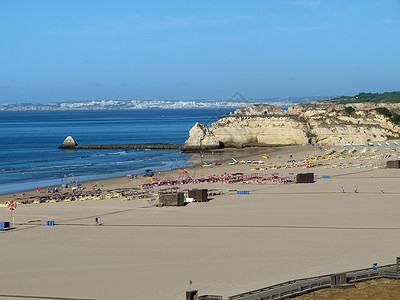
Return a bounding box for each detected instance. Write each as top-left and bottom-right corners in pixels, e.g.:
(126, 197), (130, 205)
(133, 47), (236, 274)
(183, 110), (400, 150)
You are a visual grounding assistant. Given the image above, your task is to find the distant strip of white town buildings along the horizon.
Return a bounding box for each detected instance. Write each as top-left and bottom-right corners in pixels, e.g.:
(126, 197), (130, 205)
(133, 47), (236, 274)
(0, 95), (332, 111)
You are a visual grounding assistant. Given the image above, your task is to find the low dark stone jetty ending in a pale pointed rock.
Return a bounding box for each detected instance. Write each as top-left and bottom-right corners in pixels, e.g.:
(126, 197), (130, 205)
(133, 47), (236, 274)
(58, 136), (182, 150)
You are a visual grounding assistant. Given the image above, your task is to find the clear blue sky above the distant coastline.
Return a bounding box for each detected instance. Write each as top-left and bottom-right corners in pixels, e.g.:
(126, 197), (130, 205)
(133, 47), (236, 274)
(0, 0), (400, 103)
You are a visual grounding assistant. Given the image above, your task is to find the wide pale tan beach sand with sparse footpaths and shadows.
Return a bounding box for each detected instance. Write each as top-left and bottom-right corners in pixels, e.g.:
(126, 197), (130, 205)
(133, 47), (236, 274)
(0, 146), (400, 299)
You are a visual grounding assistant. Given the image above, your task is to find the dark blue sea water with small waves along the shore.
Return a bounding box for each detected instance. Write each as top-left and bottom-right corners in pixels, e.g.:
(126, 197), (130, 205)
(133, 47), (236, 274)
(0, 109), (233, 193)
